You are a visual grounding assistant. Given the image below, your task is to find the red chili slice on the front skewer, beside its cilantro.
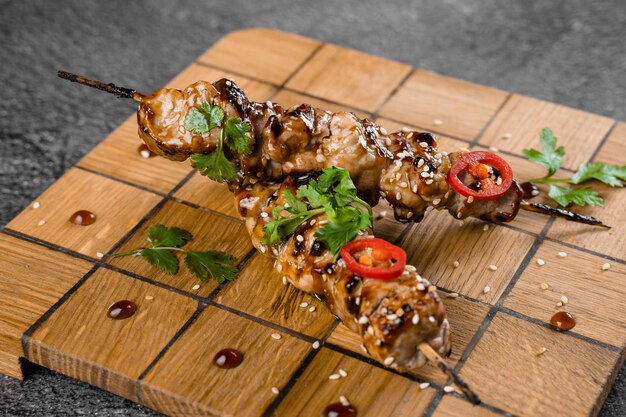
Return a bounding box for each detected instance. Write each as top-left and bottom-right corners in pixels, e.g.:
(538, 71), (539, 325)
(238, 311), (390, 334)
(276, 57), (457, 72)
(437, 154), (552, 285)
(339, 238), (406, 279)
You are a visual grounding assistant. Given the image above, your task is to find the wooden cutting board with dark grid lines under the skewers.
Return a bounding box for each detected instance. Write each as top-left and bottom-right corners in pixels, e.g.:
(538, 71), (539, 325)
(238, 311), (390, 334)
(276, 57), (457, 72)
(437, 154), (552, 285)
(0, 29), (626, 417)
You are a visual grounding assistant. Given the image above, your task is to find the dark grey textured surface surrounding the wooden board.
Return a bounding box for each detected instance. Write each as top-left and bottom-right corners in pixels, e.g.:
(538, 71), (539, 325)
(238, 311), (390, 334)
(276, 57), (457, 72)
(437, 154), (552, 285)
(0, 0), (626, 417)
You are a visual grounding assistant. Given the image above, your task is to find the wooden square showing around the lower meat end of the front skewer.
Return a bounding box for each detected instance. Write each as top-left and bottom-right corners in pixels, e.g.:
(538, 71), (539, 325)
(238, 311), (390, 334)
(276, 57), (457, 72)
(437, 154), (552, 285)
(328, 293), (489, 384)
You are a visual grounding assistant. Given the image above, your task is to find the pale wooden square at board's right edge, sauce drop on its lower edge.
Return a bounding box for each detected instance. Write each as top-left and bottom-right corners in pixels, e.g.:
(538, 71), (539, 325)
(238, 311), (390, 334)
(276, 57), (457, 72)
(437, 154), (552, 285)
(504, 237), (626, 349)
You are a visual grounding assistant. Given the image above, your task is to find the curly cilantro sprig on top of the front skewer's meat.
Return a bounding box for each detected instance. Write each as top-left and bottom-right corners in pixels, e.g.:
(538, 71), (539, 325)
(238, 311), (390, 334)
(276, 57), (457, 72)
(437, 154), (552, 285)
(261, 167), (372, 257)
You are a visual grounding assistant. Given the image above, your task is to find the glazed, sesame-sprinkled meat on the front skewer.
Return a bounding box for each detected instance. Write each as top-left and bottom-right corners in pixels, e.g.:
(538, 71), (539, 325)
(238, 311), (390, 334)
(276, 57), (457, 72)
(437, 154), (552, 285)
(235, 176), (450, 370)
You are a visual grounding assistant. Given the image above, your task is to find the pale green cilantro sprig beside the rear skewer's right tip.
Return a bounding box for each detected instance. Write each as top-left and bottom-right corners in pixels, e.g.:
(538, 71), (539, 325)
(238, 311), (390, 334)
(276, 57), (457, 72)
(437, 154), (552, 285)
(523, 127), (626, 207)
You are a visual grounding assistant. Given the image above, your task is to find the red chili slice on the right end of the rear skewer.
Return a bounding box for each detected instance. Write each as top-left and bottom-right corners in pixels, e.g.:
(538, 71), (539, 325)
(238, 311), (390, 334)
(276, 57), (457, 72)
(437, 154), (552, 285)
(448, 151), (513, 200)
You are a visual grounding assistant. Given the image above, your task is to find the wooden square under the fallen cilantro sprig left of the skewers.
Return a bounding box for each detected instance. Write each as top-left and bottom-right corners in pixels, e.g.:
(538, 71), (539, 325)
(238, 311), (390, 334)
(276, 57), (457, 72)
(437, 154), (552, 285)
(109, 197), (252, 297)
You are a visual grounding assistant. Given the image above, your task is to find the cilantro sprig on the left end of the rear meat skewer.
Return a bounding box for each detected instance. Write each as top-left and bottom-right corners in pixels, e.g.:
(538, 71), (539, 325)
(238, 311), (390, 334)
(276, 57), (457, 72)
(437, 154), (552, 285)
(185, 103), (252, 182)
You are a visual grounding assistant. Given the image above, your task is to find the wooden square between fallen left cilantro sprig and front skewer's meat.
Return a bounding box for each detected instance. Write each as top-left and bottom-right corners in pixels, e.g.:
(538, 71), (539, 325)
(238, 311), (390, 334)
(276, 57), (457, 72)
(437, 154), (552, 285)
(216, 254), (335, 338)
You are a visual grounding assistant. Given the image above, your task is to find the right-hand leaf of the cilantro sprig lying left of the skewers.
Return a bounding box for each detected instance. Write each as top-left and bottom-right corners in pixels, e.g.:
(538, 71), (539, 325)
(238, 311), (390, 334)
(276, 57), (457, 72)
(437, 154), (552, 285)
(185, 250), (239, 284)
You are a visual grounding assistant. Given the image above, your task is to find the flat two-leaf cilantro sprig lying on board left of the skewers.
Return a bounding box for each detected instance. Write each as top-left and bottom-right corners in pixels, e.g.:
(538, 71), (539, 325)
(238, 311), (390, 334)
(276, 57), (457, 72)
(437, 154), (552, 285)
(113, 224), (239, 284)
